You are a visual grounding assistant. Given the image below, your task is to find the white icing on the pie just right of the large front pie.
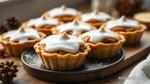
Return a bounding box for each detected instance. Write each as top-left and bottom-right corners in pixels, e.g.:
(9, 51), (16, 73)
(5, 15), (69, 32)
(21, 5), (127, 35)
(80, 30), (119, 43)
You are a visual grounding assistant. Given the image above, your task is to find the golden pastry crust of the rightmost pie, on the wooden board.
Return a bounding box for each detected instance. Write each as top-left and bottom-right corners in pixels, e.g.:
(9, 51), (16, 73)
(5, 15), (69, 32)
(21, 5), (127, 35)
(110, 24), (146, 45)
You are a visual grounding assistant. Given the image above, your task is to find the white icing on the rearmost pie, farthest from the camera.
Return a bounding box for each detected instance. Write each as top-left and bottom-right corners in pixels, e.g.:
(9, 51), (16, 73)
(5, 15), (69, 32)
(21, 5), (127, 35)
(48, 6), (78, 17)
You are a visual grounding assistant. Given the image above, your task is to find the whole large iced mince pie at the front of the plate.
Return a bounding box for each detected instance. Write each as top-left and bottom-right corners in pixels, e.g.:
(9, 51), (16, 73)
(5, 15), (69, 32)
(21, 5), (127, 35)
(34, 33), (90, 70)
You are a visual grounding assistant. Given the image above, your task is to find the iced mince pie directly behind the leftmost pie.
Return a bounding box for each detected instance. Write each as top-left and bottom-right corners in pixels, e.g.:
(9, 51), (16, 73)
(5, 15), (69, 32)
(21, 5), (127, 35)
(22, 17), (61, 35)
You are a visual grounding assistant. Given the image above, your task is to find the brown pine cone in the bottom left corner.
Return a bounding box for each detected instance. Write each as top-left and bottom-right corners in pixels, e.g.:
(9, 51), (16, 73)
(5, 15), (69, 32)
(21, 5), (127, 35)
(0, 60), (18, 84)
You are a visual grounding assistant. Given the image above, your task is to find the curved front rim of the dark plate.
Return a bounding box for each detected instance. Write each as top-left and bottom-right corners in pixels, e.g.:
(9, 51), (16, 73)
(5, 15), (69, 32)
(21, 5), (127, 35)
(21, 48), (125, 75)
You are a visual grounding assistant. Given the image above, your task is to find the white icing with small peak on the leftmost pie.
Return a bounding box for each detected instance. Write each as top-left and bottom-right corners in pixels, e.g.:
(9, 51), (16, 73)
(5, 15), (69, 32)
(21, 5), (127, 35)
(4, 28), (40, 43)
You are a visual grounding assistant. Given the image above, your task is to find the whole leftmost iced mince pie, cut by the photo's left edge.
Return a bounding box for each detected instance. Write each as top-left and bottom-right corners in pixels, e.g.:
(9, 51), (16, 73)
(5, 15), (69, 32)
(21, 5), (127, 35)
(0, 28), (46, 57)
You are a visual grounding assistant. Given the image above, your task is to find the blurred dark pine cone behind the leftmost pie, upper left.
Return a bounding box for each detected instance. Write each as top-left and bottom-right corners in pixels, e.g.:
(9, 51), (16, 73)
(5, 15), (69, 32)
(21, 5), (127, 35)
(5, 17), (20, 30)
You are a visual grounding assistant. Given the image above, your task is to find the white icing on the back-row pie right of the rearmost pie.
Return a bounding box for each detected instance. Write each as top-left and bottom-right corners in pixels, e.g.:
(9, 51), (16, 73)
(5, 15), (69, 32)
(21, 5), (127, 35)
(81, 12), (111, 22)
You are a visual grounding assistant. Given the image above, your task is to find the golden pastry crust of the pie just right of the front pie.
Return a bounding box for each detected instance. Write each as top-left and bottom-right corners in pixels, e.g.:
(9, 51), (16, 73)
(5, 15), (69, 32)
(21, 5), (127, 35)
(81, 35), (125, 59)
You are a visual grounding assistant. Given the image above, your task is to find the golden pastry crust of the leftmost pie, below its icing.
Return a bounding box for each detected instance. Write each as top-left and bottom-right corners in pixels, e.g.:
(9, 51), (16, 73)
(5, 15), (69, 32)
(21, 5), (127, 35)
(0, 32), (46, 57)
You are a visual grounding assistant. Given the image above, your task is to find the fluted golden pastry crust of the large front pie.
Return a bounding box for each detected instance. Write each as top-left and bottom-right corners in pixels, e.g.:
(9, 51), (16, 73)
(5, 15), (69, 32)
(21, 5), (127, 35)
(34, 43), (90, 70)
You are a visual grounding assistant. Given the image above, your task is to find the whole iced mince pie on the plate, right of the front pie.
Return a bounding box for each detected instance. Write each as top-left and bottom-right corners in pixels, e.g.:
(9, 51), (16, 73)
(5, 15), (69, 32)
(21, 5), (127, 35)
(80, 26), (125, 59)
